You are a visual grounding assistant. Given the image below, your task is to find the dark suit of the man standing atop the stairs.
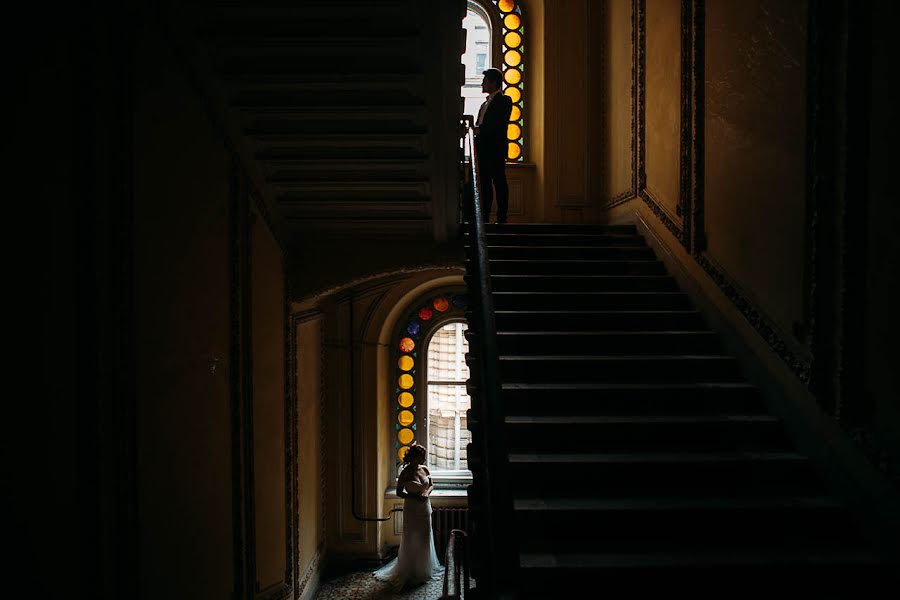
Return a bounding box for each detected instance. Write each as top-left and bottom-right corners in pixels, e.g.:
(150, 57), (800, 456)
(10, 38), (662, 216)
(475, 93), (512, 223)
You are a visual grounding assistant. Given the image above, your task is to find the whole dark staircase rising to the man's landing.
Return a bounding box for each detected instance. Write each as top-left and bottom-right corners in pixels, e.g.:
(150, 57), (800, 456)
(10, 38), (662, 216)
(470, 225), (889, 598)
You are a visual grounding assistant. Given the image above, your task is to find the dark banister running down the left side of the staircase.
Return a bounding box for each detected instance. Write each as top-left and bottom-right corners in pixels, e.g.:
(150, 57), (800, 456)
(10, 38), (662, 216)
(462, 118), (518, 598)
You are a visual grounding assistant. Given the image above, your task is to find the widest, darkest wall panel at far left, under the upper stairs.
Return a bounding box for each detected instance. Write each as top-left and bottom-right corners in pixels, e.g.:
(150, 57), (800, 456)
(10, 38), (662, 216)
(134, 21), (233, 600)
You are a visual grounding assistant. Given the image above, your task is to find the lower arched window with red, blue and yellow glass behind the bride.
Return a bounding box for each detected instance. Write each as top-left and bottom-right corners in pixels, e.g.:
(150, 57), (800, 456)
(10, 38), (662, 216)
(391, 288), (470, 479)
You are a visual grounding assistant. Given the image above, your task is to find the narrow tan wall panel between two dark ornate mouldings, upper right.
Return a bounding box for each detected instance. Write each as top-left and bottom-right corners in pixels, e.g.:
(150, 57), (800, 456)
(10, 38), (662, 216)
(644, 0), (681, 221)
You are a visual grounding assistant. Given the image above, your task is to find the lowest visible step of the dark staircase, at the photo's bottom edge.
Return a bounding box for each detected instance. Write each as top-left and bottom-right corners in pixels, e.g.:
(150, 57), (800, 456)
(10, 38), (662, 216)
(517, 541), (897, 600)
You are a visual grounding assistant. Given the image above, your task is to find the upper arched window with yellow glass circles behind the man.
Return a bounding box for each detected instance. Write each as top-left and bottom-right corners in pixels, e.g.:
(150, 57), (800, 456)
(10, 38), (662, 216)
(462, 0), (525, 161)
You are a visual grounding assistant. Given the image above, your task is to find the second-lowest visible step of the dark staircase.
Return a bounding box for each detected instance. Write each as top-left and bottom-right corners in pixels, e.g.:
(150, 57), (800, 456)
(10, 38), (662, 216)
(514, 496), (862, 554)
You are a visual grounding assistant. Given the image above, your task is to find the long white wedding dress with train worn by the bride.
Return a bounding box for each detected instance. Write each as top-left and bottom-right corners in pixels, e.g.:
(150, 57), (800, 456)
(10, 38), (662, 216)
(374, 482), (444, 589)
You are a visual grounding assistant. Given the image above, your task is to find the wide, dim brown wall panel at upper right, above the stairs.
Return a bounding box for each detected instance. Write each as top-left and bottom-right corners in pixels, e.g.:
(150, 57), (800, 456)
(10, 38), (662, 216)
(712, 0), (807, 334)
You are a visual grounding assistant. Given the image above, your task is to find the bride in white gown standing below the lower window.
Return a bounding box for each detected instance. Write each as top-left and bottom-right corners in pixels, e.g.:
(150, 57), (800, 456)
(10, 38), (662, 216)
(374, 444), (443, 589)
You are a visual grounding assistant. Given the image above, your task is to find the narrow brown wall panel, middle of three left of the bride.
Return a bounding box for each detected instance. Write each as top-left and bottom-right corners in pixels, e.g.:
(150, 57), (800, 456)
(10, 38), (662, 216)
(250, 215), (287, 591)
